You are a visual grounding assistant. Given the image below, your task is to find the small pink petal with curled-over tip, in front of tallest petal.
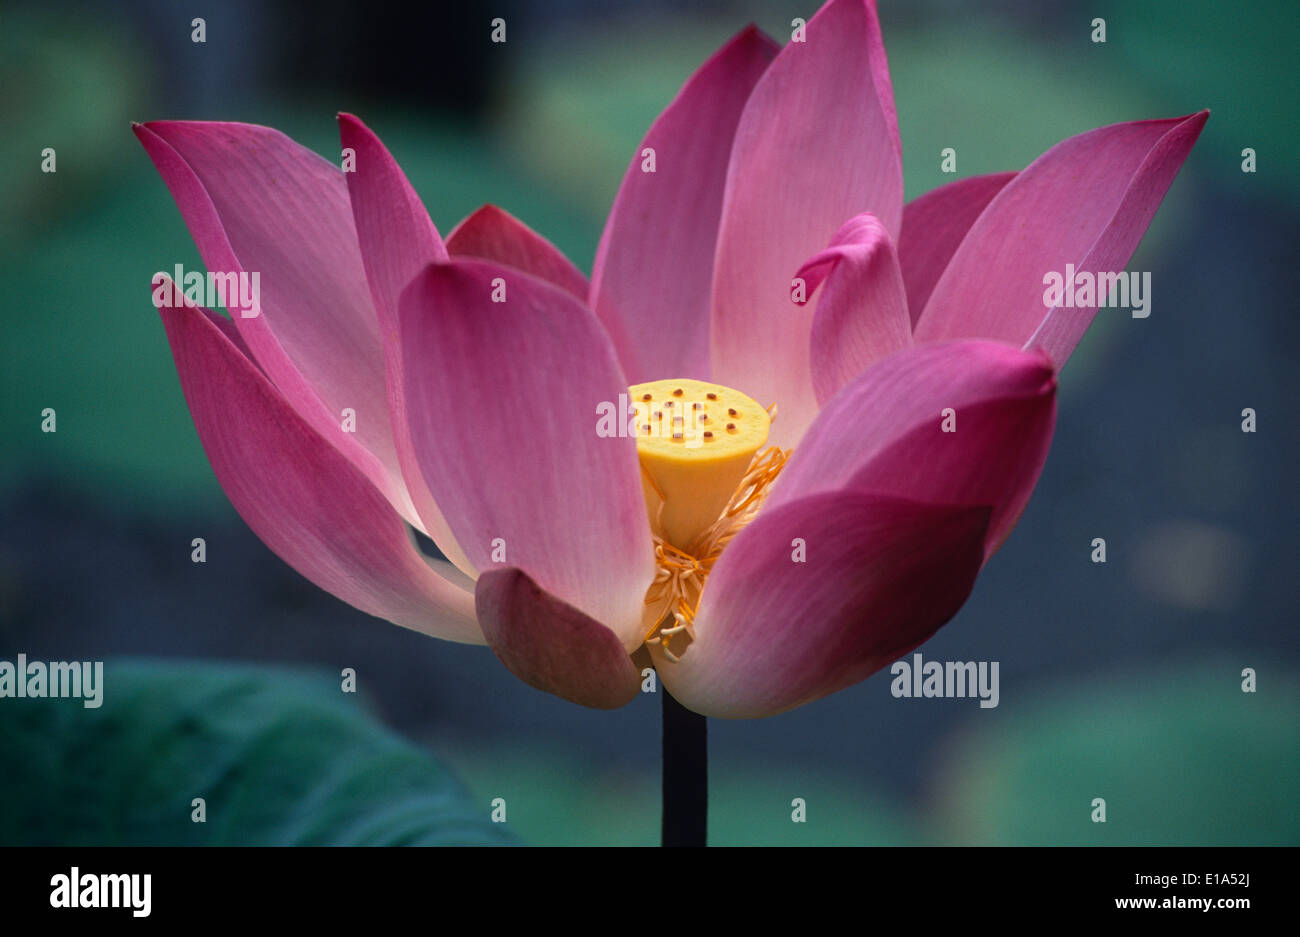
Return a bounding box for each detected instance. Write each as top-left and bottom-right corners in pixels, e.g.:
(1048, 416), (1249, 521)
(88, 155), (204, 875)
(796, 213), (911, 405)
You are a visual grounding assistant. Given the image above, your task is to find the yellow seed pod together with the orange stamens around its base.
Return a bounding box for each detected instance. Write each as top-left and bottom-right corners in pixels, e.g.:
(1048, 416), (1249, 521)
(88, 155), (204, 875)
(628, 379), (790, 661)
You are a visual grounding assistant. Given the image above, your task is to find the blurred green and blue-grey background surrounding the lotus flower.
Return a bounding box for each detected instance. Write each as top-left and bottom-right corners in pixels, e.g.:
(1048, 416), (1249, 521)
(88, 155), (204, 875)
(0, 0), (1300, 845)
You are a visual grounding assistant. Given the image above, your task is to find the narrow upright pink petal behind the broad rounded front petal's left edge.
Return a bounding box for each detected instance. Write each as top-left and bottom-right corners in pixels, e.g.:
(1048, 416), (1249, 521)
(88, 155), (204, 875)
(338, 114), (473, 574)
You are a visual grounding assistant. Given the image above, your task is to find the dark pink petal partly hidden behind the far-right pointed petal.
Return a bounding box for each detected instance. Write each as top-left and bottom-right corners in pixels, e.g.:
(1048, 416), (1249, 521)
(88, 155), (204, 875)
(898, 173), (1015, 325)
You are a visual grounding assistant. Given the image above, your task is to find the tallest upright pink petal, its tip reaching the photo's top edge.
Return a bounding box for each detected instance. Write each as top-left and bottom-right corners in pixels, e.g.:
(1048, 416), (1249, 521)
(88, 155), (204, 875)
(711, 0), (902, 446)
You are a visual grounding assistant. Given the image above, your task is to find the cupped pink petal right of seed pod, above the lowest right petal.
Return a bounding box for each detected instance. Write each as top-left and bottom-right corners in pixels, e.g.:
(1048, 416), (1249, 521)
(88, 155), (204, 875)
(764, 342), (1056, 556)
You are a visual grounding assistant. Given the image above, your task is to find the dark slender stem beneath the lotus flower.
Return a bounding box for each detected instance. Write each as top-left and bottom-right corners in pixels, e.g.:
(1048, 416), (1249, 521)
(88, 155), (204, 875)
(660, 686), (709, 846)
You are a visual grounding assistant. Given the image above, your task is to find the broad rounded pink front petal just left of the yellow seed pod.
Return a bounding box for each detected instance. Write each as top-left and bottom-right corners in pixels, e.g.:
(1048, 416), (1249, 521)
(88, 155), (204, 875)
(400, 260), (654, 651)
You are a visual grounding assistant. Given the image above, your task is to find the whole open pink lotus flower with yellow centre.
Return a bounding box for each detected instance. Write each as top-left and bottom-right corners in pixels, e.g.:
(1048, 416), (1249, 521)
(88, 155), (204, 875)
(135, 0), (1206, 717)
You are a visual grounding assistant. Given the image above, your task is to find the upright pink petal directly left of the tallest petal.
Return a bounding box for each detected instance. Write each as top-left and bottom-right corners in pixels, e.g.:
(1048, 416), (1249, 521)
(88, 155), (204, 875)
(592, 26), (777, 383)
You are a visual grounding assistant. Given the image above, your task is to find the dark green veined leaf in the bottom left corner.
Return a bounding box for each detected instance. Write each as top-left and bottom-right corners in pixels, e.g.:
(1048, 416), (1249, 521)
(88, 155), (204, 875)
(0, 660), (515, 846)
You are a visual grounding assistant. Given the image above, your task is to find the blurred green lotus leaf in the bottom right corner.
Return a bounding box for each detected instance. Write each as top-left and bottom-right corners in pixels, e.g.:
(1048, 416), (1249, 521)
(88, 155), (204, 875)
(941, 652), (1300, 846)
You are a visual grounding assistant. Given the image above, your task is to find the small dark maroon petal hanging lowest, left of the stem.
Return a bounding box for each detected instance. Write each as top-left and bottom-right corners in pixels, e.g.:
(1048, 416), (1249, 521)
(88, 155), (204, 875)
(476, 567), (641, 710)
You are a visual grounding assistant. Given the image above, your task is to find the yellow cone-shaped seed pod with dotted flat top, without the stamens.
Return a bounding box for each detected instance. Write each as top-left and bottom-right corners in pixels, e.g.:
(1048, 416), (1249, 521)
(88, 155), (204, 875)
(628, 379), (772, 550)
